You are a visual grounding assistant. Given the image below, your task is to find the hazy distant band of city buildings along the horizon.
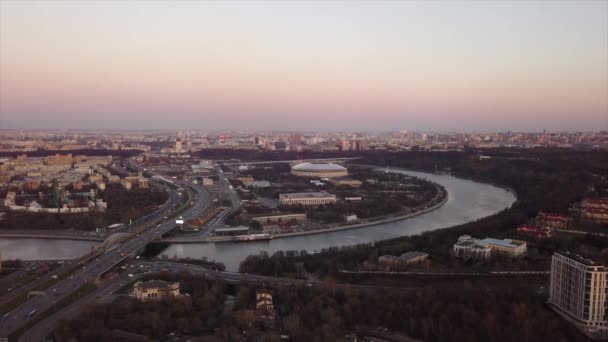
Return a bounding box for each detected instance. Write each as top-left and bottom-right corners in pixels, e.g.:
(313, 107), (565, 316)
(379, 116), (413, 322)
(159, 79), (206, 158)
(0, 129), (608, 154)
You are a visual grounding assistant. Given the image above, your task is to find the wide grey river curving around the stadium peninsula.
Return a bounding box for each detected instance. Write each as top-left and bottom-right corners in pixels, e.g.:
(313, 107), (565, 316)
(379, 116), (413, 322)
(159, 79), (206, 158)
(0, 170), (516, 271)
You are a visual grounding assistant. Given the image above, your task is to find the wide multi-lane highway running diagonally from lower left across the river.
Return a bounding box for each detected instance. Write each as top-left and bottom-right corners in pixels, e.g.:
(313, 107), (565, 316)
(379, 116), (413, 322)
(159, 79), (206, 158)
(0, 178), (211, 337)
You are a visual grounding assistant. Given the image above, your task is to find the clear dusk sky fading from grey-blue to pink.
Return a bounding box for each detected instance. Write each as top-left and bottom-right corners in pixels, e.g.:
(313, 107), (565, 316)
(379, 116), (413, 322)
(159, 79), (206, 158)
(0, 0), (608, 131)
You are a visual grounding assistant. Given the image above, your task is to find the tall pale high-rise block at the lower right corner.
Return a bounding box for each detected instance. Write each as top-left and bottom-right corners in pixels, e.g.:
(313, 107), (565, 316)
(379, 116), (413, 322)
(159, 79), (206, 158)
(549, 252), (608, 339)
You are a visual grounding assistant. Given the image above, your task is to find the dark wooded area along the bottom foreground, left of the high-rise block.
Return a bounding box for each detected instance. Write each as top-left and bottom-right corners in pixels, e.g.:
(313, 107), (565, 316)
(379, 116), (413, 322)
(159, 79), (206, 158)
(57, 276), (586, 342)
